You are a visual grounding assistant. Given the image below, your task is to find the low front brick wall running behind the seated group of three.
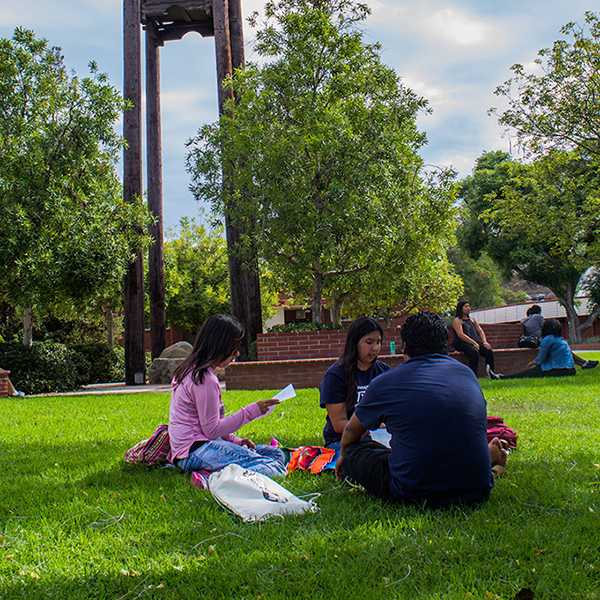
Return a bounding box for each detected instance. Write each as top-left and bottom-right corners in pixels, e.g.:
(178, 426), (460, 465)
(225, 348), (536, 390)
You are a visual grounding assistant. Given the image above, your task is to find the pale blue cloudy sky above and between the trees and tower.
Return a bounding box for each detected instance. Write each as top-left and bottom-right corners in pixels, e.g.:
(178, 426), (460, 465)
(0, 0), (595, 227)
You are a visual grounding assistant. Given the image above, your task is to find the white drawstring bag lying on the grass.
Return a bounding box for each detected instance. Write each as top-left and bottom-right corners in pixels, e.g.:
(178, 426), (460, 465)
(208, 465), (319, 523)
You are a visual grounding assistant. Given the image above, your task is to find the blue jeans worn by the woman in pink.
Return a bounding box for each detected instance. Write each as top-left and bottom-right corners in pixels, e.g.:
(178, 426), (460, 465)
(177, 440), (286, 477)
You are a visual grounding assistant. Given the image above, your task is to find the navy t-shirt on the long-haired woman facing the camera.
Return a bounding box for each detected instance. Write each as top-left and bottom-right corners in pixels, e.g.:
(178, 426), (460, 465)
(319, 360), (390, 446)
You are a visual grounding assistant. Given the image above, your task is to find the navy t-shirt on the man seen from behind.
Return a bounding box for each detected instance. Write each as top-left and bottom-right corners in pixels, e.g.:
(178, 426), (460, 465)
(356, 354), (493, 502)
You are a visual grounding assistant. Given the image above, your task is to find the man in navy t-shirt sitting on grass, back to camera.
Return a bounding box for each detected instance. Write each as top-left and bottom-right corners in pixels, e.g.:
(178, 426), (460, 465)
(336, 312), (506, 506)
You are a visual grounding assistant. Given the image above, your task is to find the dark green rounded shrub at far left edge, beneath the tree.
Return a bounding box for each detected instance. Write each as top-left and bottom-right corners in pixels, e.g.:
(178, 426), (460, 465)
(0, 342), (79, 394)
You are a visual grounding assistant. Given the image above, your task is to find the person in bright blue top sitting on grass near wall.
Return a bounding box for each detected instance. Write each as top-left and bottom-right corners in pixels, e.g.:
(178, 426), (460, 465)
(495, 319), (577, 379)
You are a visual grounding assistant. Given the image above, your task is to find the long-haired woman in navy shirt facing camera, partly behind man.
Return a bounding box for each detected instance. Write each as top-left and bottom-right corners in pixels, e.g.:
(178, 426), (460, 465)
(319, 317), (390, 450)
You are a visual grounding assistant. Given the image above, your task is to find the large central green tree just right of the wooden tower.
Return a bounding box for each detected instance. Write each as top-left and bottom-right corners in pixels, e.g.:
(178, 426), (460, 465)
(189, 0), (454, 323)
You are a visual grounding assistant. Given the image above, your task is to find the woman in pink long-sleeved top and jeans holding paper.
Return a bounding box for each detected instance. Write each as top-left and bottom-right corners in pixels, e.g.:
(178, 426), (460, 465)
(169, 315), (285, 477)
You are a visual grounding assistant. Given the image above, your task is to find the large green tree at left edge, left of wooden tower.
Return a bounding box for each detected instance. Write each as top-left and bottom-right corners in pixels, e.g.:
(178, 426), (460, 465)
(0, 29), (148, 344)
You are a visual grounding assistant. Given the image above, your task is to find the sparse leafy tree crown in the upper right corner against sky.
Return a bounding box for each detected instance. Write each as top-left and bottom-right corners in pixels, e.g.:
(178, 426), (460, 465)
(491, 11), (600, 159)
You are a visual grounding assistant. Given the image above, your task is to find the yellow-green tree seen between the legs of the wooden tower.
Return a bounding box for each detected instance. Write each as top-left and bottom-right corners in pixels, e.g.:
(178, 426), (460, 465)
(165, 218), (230, 332)
